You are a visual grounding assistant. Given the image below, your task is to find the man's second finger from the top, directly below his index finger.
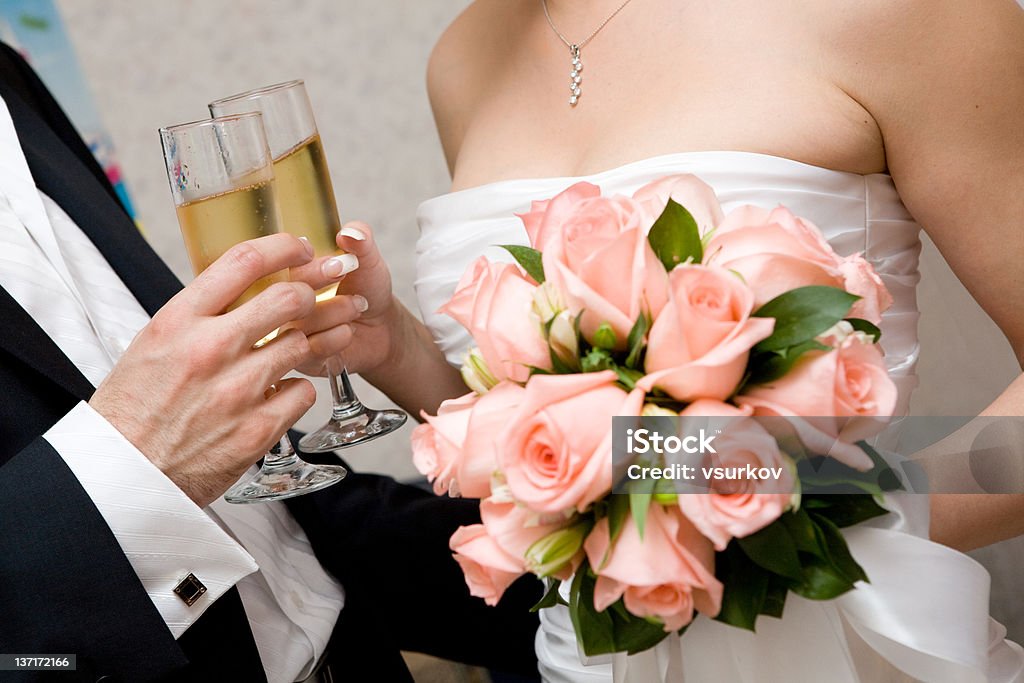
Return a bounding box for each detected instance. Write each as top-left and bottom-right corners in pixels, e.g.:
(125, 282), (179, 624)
(220, 283), (316, 348)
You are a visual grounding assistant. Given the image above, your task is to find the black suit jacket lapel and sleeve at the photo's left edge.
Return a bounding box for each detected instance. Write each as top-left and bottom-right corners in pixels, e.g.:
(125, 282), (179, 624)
(0, 45), (272, 681)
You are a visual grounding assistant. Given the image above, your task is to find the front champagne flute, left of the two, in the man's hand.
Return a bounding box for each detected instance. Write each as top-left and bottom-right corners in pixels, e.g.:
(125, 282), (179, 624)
(160, 114), (347, 503)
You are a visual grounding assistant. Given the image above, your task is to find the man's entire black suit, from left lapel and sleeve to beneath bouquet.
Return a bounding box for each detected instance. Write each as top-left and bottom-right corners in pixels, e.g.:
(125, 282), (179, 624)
(0, 43), (540, 683)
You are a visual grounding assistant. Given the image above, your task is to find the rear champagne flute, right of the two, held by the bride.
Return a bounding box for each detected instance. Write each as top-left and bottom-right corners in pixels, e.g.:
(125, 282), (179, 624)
(210, 80), (408, 453)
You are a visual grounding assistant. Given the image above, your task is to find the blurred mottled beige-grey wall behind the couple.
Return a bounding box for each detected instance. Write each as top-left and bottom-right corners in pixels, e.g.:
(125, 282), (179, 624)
(34, 0), (1024, 638)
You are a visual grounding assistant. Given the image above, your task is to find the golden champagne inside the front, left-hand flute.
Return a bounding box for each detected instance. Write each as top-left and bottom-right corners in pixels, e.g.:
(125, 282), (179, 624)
(177, 181), (288, 310)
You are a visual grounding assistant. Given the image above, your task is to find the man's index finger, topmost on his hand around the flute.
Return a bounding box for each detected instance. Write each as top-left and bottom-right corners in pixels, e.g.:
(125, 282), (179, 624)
(182, 232), (313, 315)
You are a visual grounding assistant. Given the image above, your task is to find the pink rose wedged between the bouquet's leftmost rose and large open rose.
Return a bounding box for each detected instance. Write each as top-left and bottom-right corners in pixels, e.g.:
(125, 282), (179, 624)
(462, 381), (525, 498)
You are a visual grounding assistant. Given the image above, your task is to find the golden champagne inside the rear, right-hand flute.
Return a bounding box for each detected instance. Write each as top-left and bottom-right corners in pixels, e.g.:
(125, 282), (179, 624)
(273, 134), (341, 300)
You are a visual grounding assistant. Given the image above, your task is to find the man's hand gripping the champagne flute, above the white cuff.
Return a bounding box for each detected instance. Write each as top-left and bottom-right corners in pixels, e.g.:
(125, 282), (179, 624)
(89, 233), (316, 506)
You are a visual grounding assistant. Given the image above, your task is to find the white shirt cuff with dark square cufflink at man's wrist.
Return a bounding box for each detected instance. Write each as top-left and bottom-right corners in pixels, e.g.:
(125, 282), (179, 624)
(43, 401), (258, 638)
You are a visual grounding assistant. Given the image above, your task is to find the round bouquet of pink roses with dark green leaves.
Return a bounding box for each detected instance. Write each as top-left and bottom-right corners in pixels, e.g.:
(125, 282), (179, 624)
(413, 175), (898, 654)
